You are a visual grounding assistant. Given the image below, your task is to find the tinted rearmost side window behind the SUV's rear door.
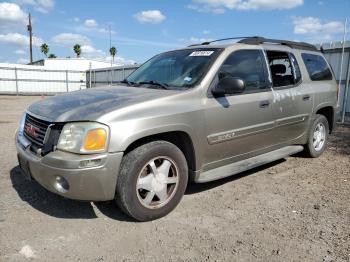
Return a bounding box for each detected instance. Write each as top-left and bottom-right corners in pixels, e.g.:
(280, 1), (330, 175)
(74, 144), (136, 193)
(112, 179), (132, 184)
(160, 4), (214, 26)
(301, 53), (333, 81)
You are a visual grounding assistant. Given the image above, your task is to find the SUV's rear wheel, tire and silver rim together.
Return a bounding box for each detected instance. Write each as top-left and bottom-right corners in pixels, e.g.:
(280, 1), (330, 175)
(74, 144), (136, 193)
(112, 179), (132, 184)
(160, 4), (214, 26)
(305, 115), (329, 158)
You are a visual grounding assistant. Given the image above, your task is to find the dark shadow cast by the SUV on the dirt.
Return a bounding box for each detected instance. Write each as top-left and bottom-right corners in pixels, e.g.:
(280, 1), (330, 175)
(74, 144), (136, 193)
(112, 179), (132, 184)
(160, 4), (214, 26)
(10, 159), (285, 222)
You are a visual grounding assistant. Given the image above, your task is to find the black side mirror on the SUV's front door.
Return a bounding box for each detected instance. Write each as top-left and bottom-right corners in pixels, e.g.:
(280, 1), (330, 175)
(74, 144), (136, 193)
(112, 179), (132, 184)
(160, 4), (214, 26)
(212, 76), (245, 96)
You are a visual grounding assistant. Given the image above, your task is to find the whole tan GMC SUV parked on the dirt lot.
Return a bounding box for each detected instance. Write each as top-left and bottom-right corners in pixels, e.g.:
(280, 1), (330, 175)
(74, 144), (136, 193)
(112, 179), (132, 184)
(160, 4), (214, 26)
(16, 37), (338, 221)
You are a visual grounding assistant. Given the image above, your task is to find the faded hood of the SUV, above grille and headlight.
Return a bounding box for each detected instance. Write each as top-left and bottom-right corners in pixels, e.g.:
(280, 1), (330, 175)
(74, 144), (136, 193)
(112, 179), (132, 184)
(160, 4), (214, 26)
(27, 86), (176, 122)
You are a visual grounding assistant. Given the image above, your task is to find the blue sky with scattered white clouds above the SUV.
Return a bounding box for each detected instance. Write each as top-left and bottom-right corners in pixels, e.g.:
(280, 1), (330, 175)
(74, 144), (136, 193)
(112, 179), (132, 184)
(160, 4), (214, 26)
(0, 0), (350, 64)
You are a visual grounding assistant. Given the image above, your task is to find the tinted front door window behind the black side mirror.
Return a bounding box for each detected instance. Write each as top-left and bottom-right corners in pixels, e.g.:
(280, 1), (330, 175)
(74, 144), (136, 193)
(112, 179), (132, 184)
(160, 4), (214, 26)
(218, 50), (268, 92)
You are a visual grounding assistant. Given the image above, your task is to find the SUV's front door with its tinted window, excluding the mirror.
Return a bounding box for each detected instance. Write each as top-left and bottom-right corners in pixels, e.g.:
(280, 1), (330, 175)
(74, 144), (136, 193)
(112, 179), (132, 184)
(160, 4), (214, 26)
(203, 49), (275, 170)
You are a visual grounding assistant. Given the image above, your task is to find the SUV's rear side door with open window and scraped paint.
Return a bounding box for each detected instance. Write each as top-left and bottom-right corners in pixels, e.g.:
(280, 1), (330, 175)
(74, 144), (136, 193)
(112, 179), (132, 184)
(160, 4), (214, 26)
(266, 51), (313, 144)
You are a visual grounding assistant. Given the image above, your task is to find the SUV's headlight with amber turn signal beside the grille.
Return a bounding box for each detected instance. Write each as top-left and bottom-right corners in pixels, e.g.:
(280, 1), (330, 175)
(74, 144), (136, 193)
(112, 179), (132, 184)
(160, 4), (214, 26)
(57, 122), (109, 154)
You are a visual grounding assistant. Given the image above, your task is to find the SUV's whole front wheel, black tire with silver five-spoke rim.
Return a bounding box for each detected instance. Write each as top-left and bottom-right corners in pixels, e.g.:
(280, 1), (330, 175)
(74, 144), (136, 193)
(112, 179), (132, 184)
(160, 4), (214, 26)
(115, 141), (188, 221)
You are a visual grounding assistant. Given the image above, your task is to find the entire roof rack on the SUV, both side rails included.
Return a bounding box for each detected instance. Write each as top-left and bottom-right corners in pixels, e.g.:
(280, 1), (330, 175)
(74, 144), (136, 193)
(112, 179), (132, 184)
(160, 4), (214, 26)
(190, 36), (318, 51)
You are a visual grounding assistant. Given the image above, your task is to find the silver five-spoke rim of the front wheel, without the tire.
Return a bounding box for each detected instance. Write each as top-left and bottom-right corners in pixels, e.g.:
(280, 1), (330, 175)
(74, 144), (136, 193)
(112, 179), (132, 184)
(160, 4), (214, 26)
(136, 156), (179, 209)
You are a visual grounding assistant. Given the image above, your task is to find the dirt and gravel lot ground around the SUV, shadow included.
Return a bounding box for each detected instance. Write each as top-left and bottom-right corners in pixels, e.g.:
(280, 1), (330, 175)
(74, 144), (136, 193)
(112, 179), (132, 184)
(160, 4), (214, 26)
(0, 96), (350, 261)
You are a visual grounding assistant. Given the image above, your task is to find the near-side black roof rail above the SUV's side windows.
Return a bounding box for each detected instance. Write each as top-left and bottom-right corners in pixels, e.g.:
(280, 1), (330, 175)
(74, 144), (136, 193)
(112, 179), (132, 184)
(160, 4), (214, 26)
(238, 36), (318, 51)
